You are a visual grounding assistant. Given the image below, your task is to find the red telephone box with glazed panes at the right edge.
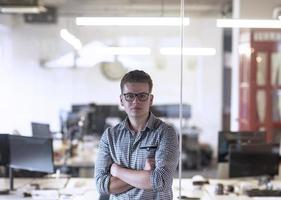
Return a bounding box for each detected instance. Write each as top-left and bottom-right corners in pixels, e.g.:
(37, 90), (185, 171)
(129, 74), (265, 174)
(239, 29), (281, 142)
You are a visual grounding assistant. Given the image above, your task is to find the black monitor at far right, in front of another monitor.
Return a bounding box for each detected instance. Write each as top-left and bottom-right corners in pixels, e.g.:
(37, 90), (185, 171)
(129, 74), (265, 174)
(229, 144), (279, 177)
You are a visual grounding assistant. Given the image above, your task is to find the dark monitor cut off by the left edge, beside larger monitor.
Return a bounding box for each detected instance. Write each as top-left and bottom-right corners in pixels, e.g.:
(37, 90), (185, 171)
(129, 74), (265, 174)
(0, 134), (10, 166)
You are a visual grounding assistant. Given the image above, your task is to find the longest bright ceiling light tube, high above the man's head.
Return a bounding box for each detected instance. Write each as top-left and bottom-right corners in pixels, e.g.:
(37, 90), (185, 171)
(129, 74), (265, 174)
(76, 17), (189, 26)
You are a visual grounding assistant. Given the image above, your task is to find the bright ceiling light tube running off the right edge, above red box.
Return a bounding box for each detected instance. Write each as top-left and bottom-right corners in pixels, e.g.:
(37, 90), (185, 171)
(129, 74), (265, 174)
(217, 19), (281, 28)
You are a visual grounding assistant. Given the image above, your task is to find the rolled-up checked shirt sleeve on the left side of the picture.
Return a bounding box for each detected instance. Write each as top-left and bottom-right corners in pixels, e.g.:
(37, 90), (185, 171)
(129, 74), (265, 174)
(95, 129), (112, 194)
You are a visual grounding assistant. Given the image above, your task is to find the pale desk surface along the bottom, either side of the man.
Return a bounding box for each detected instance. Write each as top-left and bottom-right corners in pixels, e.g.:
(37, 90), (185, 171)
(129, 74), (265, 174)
(0, 178), (281, 200)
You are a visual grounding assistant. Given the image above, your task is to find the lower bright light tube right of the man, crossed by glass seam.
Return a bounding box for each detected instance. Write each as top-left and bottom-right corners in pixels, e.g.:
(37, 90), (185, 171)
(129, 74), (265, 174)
(160, 48), (216, 56)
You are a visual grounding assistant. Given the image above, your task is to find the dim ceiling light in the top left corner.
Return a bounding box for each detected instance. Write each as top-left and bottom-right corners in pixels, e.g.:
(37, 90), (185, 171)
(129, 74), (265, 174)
(0, 6), (47, 14)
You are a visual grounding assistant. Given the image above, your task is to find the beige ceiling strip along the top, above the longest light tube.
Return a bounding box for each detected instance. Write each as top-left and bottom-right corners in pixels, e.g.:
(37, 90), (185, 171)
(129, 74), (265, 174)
(41, 0), (232, 17)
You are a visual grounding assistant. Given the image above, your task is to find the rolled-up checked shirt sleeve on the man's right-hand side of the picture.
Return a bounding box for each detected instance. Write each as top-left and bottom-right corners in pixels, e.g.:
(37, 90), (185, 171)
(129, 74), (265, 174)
(150, 125), (179, 192)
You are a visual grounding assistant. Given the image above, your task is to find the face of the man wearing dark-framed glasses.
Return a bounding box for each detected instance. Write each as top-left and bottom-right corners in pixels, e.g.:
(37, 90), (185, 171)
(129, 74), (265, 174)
(120, 82), (153, 118)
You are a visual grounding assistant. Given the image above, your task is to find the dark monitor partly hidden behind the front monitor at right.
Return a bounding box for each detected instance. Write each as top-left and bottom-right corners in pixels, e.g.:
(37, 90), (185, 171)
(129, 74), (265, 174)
(218, 131), (266, 162)
